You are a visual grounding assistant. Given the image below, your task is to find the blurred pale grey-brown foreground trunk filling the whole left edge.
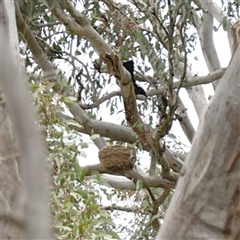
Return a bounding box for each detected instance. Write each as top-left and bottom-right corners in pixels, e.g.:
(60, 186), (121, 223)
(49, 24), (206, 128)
(0, 0), (53, 239)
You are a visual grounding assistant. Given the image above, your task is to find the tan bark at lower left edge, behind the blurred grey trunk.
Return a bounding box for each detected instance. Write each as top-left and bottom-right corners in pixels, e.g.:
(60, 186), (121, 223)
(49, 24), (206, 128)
(0, 99), (23, 239)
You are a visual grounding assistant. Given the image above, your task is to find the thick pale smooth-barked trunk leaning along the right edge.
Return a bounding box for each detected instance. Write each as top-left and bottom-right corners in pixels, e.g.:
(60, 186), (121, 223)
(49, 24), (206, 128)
(156, 48), (240, 239)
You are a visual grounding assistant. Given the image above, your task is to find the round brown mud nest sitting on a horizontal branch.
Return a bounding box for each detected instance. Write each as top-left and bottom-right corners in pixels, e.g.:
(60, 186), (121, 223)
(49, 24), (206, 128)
(98, 145), (136, 171)
